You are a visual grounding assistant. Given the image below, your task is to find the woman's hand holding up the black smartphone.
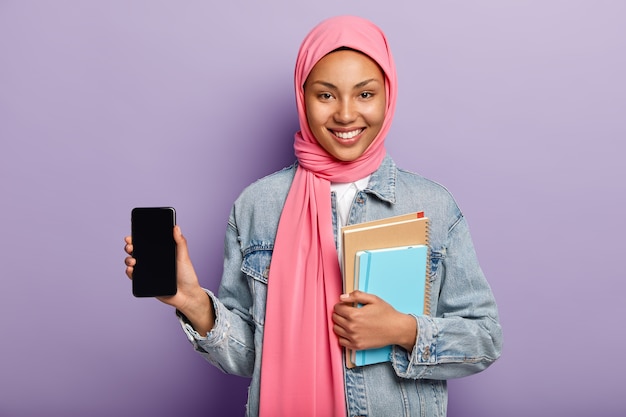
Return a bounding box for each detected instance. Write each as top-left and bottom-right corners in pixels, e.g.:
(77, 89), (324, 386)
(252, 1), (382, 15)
(124, 225), (215, 336)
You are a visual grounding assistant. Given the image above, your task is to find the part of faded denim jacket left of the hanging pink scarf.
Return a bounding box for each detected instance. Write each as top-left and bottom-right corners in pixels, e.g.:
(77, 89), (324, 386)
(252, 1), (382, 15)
(176, 165), (295, 386)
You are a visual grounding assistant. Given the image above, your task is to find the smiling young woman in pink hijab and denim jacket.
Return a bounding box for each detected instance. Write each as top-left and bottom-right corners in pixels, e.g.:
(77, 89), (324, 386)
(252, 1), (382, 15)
(125, 16), (501, 417)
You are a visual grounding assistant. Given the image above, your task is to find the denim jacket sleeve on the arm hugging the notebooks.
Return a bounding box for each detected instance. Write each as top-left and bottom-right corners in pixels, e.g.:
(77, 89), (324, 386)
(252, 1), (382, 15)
(392, 213), (502, 379)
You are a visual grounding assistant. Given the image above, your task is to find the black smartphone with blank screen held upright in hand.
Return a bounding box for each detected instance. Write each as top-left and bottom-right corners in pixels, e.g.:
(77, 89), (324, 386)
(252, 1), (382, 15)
(131, 207), (176, 297)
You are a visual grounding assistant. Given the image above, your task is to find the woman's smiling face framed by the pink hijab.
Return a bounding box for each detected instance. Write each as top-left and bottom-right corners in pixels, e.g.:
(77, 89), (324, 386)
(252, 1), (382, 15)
(304, 50), (385, 162)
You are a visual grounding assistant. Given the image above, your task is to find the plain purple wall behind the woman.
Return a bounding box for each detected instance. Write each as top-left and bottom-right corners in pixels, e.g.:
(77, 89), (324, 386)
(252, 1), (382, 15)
(0, 0), (626, 417)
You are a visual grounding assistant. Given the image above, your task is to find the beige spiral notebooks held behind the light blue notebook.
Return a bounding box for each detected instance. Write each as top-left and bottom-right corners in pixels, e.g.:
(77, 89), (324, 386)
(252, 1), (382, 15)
(341, 212), (430, 368)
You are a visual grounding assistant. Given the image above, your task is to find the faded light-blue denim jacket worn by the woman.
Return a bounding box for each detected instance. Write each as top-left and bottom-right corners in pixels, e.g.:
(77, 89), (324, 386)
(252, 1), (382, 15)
(180, 156), (502, 417)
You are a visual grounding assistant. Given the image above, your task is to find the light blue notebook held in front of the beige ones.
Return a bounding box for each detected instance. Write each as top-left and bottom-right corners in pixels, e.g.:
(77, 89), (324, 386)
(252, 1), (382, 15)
(353, 245), (428, 366)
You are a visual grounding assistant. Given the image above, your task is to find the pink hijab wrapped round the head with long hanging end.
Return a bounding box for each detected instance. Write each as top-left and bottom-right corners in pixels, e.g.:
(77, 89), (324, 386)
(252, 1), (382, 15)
(260, 16), (397, 417)
